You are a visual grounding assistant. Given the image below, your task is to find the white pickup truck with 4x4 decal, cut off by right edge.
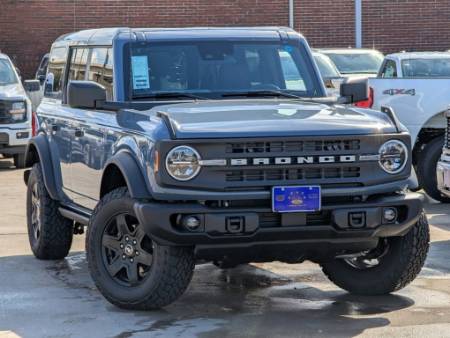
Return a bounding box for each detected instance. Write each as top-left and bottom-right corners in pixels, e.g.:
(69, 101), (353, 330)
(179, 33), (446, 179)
(368, 52), (450, 202)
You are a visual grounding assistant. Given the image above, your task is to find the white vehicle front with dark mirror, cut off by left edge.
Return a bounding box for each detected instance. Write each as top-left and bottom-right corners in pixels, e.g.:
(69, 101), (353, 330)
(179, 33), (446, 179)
(0, 53), (40, 168)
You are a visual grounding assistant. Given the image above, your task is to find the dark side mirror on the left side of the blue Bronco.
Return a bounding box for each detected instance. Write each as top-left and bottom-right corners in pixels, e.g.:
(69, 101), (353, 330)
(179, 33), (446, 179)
(67, 81), (106, 109)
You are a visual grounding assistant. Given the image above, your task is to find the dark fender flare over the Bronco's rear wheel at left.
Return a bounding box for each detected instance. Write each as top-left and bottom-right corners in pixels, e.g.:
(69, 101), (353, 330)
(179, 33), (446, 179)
(24, 134), (63, 201)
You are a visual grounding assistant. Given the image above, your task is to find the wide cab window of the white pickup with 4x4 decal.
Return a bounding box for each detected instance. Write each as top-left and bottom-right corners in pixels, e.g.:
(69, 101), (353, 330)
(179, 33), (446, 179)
(402, 58), (450, 77)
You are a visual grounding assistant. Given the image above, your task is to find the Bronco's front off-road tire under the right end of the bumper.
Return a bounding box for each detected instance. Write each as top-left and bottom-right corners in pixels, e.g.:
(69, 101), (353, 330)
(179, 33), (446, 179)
(321, 213), (430, 296)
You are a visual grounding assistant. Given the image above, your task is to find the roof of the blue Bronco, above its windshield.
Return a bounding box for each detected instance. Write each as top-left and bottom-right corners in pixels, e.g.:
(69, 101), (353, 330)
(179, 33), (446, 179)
(55, 27), (298, 45)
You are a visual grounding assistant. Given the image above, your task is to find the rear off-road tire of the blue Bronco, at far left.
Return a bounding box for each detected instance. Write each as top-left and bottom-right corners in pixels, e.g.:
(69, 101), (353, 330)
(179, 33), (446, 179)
(27, 163), (73, 260)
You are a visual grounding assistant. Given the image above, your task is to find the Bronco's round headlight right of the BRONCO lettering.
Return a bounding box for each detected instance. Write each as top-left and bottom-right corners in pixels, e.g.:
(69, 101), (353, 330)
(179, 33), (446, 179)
(379, 140), (408, 174)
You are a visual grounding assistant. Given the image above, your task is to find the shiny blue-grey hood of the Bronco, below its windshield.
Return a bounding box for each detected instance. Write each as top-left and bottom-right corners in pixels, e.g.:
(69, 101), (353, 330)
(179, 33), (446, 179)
(152, 99), (396, 139)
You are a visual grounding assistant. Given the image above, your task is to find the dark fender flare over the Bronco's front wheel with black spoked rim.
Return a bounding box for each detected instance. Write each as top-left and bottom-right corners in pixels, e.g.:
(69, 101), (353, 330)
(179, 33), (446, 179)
(100, 150), (151, 199)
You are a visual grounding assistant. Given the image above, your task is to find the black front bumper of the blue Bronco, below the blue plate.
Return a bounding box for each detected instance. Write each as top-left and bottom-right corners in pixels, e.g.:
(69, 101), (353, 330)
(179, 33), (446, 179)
(134, 193), (422, 250)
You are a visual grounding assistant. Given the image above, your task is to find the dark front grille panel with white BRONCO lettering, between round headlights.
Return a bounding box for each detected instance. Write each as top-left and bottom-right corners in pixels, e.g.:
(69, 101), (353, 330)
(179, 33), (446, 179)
(158, 133), (409, 192)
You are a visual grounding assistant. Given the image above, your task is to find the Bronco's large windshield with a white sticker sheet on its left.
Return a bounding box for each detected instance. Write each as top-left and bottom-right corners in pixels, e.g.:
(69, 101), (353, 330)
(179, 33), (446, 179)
(130, 41), (322, 98)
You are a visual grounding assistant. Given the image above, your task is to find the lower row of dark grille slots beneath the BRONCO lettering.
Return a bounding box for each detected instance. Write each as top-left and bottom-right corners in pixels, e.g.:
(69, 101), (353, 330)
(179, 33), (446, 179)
(226, 166), (360, 182)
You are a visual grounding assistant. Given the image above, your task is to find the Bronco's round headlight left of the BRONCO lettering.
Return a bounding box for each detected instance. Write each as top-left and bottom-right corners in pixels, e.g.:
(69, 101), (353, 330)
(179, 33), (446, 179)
(166, 146), (200, 181)
